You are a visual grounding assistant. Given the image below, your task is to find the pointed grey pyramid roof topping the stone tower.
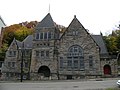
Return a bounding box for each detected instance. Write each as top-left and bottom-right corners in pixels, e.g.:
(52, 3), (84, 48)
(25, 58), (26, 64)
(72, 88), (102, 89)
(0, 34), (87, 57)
(36, 13), (55, 29)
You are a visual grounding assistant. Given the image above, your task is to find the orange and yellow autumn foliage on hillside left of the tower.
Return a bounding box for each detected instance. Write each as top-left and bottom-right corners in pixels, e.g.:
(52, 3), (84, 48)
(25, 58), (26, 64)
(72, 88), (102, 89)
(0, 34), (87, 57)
(0, 22), (35, 60)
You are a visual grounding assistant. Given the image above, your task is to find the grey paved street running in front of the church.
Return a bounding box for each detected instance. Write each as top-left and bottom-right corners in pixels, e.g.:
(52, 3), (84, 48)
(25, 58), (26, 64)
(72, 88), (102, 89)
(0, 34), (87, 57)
(0, 79), (117, 90)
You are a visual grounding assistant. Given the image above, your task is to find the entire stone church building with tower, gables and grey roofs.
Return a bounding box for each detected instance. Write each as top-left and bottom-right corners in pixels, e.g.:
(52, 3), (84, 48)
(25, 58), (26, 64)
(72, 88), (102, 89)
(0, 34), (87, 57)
(2, 13), (117, 80)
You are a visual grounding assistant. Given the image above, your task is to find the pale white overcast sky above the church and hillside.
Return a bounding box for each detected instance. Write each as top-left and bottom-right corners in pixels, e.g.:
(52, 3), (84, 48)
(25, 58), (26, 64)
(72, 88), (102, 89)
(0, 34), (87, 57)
(0, 0), (120, 34)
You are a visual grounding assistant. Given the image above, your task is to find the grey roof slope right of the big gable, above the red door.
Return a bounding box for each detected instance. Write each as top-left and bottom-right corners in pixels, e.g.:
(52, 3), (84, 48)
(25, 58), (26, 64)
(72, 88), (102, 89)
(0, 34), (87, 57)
(91, 35), (108, 54)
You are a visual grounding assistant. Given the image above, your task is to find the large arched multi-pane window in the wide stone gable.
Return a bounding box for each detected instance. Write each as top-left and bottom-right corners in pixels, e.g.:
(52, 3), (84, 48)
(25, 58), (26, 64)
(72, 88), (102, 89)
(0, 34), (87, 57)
(67, 45), (84, 70)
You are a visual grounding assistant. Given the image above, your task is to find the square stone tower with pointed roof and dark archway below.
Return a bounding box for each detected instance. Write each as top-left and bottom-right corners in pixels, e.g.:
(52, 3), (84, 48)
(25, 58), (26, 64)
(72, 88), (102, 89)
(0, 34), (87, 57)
(30, 13), (59, 80)
